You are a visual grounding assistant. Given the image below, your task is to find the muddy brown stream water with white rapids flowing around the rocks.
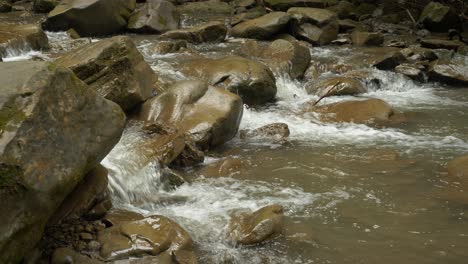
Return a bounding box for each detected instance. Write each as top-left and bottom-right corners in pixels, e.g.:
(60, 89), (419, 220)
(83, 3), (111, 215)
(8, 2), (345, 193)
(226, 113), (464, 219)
(7, 33), (468, 263)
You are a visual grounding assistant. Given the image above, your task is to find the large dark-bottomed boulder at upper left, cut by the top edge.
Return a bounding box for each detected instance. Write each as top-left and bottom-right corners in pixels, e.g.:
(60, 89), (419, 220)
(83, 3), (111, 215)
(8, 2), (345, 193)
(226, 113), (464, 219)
(42, 0), (136, 37)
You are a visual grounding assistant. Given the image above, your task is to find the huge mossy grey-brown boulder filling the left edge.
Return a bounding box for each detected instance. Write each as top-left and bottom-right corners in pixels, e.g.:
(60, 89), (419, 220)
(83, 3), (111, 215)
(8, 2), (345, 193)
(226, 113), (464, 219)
(0, 61), (125, 263)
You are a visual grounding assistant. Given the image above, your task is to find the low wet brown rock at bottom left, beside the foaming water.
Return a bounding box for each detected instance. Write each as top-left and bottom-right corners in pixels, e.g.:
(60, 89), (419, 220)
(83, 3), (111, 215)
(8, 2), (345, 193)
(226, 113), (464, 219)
(98, 215), (195, 261)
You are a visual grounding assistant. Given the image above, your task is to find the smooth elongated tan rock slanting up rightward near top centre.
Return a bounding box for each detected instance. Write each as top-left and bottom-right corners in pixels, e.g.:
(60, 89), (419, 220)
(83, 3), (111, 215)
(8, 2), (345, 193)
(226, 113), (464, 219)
(229, 12), (290, 39)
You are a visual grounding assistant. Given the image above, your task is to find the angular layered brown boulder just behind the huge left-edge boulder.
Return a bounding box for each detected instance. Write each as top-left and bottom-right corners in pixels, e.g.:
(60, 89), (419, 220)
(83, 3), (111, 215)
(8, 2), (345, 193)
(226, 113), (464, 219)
(56, 36), (156, 111)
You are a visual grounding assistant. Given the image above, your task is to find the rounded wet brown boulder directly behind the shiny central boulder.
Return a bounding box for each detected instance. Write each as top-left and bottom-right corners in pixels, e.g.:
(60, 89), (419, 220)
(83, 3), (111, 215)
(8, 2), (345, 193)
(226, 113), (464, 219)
(183, 56), (276, 105)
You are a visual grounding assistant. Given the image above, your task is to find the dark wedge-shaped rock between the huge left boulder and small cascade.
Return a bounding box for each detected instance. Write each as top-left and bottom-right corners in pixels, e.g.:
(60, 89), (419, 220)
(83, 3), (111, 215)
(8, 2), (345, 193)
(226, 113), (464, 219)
(49, 165), (109, 225)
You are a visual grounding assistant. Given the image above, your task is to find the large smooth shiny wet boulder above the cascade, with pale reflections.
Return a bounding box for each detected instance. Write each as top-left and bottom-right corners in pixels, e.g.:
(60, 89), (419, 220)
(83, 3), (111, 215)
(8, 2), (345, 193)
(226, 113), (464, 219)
(139, 81), (243, 149)
